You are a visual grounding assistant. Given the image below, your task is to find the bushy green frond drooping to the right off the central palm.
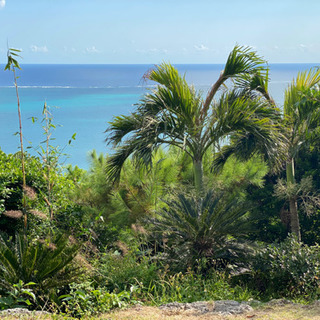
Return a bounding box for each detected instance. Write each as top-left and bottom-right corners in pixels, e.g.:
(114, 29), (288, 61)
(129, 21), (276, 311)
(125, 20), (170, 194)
(208, 96), (287, 170)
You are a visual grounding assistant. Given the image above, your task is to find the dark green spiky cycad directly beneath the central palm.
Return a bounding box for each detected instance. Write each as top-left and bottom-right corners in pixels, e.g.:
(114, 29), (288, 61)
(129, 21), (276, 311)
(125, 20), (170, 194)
(149, 191), (252, 269)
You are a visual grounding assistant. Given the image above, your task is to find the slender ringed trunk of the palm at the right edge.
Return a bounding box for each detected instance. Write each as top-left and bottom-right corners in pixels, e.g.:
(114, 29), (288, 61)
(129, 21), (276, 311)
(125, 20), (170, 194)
(286, 158), (301, 241)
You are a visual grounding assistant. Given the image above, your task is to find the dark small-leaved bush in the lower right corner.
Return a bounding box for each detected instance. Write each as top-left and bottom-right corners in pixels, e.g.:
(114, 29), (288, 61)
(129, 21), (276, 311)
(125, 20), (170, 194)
(249, 236), (320, 299)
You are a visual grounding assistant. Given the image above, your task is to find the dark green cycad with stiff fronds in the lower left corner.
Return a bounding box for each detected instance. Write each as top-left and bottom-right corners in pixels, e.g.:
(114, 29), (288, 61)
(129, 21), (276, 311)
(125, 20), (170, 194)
(0, 234), (79, 293)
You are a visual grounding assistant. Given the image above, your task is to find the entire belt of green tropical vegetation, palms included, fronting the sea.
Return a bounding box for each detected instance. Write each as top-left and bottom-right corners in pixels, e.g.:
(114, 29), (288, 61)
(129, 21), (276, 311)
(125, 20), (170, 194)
(0, 46), (320, 318)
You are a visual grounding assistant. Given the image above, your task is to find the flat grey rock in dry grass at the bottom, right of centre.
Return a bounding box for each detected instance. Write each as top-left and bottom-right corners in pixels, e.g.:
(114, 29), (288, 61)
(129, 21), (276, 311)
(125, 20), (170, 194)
(160, 300), (253, 315)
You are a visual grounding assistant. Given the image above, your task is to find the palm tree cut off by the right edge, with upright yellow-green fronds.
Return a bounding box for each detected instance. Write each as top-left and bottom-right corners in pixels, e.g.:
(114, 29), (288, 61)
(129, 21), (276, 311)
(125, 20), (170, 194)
(283, 68), (320, 241)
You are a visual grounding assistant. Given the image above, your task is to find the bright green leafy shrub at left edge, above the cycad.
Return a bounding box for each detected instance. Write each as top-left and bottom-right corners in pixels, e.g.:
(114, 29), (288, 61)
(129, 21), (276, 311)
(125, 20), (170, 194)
(0, 150), (75, 236)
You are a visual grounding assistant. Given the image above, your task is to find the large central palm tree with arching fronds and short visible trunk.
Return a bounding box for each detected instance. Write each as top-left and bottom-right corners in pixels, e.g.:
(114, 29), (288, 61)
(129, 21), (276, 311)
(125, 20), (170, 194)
(106, 46), (284, 193)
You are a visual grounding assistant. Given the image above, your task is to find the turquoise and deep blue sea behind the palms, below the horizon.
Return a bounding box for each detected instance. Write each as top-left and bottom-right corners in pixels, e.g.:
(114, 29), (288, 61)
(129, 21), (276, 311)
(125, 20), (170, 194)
(0, 64), (315, 169)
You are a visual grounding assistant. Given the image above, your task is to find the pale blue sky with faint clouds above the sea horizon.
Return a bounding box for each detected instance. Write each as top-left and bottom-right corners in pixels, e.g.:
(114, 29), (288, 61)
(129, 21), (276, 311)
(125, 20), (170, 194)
(0, 0), (320, 64)
